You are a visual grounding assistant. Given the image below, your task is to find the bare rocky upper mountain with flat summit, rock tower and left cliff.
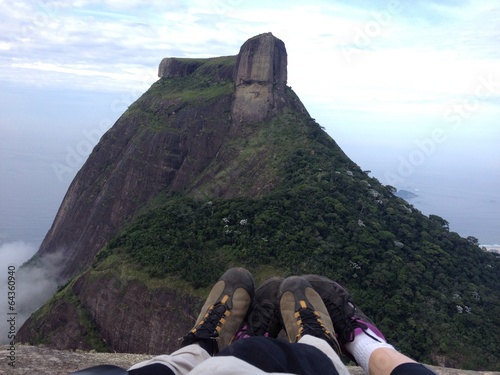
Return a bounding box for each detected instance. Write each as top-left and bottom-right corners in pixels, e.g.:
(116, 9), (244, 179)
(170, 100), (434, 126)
(39, 33), (292, 279)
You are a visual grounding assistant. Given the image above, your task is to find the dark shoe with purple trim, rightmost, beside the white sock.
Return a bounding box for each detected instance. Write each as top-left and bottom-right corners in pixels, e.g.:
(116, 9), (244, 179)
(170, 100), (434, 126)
(303, 275), (387, 356)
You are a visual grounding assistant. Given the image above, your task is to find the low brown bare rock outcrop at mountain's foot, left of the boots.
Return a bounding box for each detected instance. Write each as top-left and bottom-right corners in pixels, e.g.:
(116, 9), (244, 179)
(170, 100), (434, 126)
(18, 270), (200, 354)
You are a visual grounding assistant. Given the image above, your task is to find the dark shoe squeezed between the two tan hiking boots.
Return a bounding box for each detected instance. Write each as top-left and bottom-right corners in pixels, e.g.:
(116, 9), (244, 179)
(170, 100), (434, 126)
(236, 277), (284, 339)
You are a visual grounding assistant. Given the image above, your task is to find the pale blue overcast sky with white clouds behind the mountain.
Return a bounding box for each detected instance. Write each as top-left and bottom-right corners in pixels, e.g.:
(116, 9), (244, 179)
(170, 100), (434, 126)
(0, 0), (500, 245)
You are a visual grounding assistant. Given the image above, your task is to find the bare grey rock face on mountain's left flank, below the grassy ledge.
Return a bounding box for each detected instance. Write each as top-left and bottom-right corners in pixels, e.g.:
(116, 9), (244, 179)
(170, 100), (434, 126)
(39, 87), (232, 278)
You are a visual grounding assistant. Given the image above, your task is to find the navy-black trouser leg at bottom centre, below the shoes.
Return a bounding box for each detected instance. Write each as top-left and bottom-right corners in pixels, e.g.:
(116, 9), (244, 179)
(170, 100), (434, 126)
(216, 336), (338, 375)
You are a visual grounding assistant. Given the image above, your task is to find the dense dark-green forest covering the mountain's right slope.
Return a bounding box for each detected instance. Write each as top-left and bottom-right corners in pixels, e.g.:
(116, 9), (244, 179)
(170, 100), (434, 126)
(95, 97), (500, 369)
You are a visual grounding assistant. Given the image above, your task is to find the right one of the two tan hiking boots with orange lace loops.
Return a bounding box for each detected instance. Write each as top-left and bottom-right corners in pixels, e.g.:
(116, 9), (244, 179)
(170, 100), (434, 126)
(280, 276), (340, 353)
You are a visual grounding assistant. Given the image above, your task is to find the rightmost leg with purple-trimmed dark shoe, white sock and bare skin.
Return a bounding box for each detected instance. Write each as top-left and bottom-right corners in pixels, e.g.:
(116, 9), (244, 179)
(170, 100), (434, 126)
(304, 275), (433, 375)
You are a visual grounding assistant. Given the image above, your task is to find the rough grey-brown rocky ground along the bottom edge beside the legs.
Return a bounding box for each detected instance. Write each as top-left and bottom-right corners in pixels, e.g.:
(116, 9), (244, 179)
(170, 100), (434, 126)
(0, 345), (500, 375)
